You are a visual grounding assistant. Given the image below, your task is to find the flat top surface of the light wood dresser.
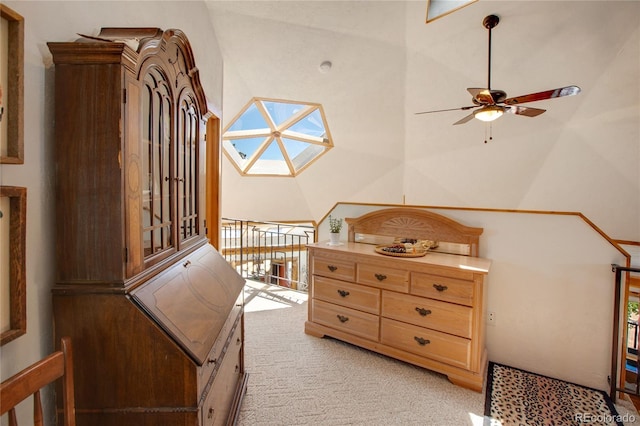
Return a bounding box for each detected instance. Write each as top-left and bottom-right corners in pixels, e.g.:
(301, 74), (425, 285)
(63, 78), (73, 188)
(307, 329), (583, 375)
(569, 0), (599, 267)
(308, 241), (491, 274)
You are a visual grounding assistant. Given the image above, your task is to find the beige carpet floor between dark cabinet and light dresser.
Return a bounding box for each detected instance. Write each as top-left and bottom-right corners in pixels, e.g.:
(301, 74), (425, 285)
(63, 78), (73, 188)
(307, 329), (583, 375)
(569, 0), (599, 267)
(238, 282), (640, 426)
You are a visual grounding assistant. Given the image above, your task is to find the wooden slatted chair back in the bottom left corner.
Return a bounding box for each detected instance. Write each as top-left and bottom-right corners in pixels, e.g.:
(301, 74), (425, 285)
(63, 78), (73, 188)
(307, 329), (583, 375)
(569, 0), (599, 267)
(0, 337), (76, 426)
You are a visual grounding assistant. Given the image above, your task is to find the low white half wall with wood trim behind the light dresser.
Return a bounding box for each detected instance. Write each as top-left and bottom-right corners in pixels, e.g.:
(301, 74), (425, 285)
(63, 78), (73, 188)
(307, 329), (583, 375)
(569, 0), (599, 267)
(318, 203), (626, 391)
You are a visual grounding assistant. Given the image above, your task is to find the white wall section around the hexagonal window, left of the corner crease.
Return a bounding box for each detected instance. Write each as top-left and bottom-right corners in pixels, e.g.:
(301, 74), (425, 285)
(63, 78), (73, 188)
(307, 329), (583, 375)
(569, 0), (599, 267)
(212, 1), (405, 220)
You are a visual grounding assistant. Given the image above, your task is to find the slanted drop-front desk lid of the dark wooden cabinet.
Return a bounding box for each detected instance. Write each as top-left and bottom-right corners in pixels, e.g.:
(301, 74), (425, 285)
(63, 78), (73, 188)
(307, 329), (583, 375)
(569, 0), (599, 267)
(131, 244), (244, 365)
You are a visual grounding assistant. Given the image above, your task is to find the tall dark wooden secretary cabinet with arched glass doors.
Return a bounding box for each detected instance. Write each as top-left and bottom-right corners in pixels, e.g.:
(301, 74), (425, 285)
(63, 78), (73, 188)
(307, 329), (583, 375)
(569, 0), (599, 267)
(48, 28), (247, 426)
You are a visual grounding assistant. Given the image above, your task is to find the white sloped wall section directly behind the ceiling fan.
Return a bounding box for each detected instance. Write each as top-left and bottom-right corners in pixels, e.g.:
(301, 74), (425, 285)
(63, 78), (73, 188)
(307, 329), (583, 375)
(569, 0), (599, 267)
(404, 1), (640, 241)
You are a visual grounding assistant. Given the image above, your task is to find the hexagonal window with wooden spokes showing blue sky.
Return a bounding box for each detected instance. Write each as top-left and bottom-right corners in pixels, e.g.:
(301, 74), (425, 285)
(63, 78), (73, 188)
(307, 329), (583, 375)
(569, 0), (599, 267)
(222, 98), (333, 176)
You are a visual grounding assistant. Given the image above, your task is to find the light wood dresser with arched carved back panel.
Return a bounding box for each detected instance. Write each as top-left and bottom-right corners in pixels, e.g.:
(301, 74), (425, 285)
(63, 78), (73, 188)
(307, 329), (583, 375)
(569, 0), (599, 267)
(305, 208), (491, 391)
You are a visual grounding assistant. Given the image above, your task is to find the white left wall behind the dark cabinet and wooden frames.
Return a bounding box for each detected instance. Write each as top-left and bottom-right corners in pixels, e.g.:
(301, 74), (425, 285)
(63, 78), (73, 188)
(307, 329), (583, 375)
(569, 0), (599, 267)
(0, 0), (222, 424)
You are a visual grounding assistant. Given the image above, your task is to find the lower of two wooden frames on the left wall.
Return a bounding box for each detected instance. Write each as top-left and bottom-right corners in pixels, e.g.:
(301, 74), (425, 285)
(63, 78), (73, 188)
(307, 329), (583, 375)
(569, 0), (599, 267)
(0, 186), (27, 345)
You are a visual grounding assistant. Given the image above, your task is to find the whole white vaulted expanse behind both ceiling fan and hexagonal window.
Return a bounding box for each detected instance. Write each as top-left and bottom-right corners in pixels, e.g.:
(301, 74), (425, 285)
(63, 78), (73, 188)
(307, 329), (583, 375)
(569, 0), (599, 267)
(207, 0), (640, 240)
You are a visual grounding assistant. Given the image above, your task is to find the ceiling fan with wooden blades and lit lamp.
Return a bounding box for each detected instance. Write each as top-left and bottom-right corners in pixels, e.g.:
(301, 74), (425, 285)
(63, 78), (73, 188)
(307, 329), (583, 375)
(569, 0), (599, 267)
(416, 15), (580, 125)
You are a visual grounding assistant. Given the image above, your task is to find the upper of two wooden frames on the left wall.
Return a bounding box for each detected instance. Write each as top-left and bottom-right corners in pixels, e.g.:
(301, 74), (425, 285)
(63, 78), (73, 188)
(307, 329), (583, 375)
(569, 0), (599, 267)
(0, 4), (24, 164)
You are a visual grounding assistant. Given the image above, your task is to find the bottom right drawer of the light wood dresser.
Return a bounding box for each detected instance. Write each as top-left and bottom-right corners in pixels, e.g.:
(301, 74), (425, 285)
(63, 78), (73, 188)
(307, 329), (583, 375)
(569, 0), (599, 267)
(380, 318), (471, 369)
